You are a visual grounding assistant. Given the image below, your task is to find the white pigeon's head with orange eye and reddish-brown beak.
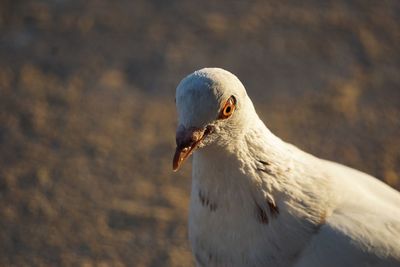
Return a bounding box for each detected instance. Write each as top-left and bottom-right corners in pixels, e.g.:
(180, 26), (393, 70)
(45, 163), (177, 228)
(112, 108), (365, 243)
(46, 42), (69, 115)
(173, 68), (255, 171)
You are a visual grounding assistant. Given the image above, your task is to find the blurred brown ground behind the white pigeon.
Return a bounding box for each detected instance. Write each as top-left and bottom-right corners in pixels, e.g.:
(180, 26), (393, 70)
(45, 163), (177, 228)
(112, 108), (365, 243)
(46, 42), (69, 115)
(0, 0), (400, 266)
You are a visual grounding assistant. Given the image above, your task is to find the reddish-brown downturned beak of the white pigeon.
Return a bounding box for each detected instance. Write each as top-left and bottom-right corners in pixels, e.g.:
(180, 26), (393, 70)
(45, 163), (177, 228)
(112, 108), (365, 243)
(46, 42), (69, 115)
(172, 125), (211, 172)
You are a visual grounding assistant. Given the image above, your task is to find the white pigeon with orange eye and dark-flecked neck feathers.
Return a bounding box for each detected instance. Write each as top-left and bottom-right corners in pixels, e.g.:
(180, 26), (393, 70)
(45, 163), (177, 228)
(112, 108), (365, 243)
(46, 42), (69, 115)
(173, 68), (400, 267)
